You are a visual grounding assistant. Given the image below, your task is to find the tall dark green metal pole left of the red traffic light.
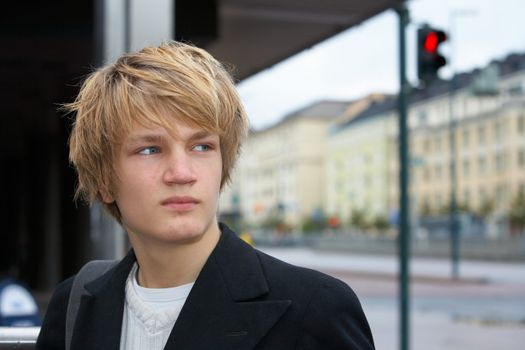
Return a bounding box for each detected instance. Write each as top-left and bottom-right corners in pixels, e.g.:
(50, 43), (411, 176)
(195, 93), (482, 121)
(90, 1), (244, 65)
(396, 4), (410, 350)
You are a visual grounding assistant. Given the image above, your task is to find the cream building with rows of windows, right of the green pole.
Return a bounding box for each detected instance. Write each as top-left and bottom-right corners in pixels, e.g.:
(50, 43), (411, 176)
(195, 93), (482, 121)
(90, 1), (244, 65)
(411, 64), (525, 216)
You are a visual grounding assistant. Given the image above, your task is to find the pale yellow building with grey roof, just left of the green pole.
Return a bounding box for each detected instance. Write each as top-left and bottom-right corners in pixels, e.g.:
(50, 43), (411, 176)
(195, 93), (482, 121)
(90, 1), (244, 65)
(325, 98), (396, 225)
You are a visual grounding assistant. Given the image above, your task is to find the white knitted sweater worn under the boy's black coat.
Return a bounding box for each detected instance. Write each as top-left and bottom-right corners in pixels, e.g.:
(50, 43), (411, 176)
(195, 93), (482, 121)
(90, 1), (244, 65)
(120, 264), (193, 350)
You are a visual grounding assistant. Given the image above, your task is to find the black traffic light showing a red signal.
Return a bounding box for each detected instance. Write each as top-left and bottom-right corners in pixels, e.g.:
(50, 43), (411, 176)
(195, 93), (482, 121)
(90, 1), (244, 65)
(417, 25), (447, 84)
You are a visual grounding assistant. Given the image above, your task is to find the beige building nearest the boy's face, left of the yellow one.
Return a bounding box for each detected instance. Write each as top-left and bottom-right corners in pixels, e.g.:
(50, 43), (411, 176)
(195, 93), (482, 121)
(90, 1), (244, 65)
(228, 101), (348, 229)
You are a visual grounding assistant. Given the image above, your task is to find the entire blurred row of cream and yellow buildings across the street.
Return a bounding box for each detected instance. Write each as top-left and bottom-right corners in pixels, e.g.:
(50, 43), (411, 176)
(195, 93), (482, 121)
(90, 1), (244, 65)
(222, 54), (525, 241)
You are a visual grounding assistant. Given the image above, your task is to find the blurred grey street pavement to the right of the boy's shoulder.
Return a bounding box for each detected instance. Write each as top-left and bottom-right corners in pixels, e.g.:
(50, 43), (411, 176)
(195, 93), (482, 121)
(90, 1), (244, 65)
(259, 247), (525, 350)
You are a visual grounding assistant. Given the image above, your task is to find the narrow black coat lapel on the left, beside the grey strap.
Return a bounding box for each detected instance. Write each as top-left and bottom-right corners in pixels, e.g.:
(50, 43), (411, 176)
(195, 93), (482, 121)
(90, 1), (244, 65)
(71, 251), (135, 350)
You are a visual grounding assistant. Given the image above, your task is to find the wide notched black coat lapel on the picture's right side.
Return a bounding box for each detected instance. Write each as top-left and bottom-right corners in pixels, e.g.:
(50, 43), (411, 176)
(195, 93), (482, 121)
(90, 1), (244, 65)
(165, 225), (291, 350)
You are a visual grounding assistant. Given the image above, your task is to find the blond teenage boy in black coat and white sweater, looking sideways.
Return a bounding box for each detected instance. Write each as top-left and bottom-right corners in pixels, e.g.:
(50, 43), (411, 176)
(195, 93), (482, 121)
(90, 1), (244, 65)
(37, 42), (374, 350)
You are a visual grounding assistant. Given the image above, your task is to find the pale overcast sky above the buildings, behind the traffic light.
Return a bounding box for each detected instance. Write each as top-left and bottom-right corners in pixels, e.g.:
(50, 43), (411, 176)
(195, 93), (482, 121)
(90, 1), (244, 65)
(238, 0), (525, 129)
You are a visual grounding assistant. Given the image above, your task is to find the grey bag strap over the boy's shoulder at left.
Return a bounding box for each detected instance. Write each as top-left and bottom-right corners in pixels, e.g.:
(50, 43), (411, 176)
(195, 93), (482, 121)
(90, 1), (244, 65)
(65, 260), (118, 350)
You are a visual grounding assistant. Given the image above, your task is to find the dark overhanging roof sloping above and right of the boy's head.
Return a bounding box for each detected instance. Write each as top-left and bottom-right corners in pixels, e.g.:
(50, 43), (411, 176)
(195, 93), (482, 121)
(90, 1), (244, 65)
(206, 0), (403, 80)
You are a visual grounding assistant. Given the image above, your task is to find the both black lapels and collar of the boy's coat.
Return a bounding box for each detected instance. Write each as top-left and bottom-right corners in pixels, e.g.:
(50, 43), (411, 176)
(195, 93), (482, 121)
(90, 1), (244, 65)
(72, 224), (291, 350)
